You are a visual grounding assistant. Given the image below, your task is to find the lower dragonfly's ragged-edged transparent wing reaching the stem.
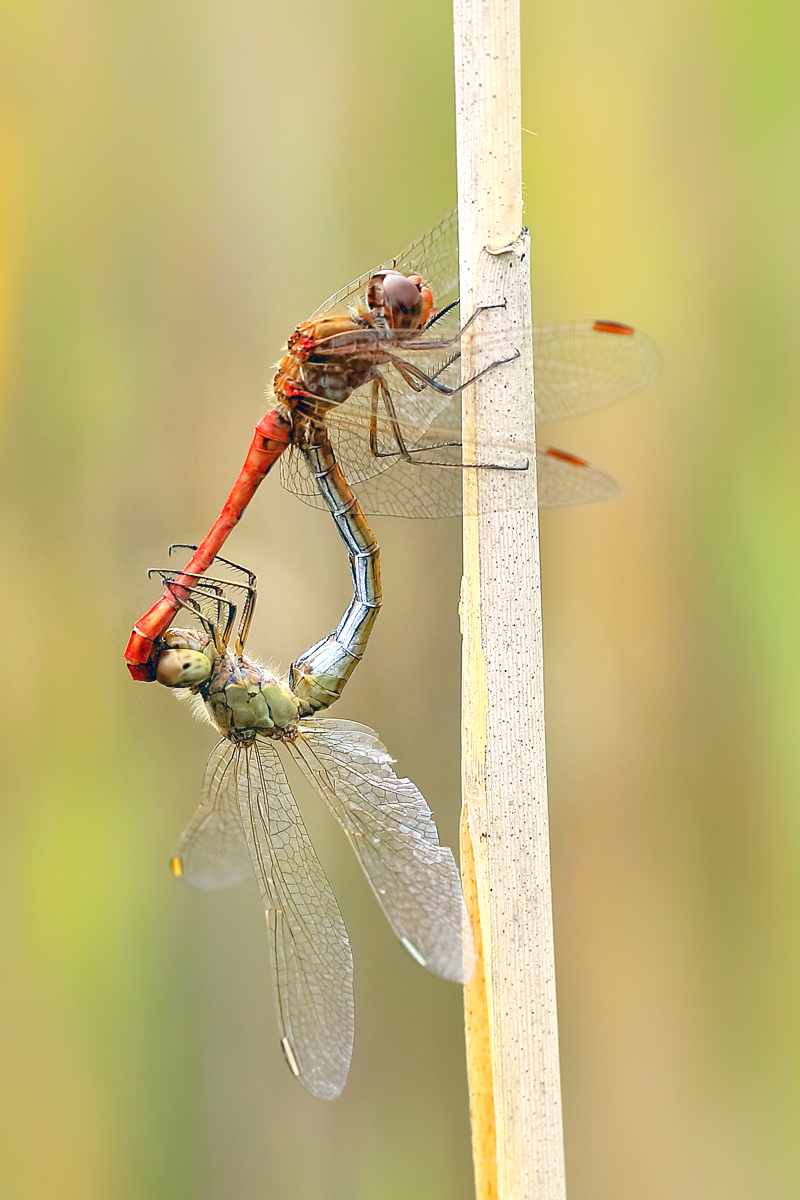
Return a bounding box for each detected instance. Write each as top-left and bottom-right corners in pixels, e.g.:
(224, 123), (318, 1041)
(290, 719), (474, 983)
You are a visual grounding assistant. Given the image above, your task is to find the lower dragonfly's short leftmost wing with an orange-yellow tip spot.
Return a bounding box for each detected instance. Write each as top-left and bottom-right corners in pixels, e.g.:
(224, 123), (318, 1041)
(172, 740), (251, 890)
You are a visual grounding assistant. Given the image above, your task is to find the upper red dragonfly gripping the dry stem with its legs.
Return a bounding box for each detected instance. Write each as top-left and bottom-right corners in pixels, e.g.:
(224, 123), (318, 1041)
(125, 211), (661, 679)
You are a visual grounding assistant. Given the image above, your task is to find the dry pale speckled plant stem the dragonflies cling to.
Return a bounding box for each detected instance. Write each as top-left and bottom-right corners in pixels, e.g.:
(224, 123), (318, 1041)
(453, 0), (565, 1200)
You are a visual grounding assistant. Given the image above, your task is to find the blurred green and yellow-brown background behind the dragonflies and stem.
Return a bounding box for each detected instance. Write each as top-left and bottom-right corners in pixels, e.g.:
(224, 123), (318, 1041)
(0, 0), (800, 1200)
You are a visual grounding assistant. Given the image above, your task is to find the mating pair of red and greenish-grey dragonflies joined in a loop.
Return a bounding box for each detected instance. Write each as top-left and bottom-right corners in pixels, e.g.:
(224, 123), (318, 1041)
(136, 214), (660, 1098)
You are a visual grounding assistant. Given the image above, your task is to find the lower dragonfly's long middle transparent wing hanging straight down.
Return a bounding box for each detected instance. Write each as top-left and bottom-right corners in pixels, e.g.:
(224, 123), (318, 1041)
(232, 738), (354, 1100)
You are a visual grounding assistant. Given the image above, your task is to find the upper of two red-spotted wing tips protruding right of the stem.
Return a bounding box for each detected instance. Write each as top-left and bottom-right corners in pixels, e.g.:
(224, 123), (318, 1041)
(534, 320), (661, 421)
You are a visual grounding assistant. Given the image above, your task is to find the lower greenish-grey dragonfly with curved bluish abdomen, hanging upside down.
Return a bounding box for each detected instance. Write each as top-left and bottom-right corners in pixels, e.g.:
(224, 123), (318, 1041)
(155, 439), (475, 1099)
